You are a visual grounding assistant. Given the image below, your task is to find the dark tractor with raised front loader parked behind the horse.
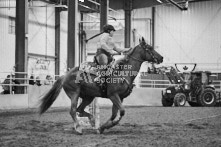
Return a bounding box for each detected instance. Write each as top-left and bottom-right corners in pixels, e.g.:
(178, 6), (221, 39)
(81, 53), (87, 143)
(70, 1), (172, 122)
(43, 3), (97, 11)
(162, 67), (220, 107)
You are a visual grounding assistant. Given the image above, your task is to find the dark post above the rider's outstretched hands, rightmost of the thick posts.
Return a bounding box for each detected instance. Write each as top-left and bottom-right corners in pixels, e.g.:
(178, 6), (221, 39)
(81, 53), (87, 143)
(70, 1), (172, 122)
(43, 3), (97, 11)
(124, 0), (132, 48)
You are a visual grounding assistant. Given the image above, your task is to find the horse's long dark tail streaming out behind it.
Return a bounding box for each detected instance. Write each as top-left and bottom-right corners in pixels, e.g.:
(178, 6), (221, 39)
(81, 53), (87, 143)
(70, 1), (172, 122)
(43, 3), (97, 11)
(39, 76), (64, 115)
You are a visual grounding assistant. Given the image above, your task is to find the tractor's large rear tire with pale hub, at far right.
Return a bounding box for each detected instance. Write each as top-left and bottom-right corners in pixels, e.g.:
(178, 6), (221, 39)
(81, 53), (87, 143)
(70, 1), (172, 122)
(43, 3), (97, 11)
(197, 89), (216, 107)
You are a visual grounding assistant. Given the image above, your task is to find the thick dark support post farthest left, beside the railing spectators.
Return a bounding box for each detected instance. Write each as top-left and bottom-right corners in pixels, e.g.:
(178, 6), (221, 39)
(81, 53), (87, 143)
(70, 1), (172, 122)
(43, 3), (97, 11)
(15, 0), (28, 93)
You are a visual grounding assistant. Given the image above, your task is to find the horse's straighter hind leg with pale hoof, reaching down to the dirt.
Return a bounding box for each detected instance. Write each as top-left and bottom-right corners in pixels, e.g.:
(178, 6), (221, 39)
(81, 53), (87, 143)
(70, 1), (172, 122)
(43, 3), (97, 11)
(66, 92), (82, 134)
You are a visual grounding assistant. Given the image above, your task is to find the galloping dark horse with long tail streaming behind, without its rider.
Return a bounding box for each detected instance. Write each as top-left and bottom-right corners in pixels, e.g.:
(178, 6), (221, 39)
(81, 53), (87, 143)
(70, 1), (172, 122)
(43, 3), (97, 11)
(39, 38), (163, 134)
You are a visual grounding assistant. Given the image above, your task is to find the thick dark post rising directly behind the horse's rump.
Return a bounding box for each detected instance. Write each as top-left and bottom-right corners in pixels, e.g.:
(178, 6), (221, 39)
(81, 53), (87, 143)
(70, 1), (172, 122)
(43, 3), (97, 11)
(67, 0), (78, 70)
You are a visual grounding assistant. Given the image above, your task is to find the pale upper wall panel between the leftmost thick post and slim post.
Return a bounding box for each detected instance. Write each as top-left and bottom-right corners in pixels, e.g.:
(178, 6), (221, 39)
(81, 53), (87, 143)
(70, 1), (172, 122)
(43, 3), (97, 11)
(28, 1), (55, 56)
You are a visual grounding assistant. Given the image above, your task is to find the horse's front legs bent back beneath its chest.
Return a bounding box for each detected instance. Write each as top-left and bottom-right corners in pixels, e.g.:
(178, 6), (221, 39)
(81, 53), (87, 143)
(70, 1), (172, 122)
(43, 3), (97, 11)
(99, 94), (125, 134)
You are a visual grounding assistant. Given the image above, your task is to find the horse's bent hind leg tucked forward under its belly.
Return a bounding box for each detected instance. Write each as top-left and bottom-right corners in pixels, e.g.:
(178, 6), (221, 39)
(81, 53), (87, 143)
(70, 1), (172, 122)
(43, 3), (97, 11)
(77, 97), (95, 127)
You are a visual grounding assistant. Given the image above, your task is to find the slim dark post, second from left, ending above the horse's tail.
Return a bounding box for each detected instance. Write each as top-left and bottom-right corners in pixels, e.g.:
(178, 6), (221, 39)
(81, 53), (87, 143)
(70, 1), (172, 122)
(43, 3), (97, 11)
(55, 8), (61, 79)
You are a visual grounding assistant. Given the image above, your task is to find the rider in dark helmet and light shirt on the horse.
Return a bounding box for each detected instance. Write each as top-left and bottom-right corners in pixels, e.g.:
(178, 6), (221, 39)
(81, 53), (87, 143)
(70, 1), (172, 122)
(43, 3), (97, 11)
(95, 24), (129, 81)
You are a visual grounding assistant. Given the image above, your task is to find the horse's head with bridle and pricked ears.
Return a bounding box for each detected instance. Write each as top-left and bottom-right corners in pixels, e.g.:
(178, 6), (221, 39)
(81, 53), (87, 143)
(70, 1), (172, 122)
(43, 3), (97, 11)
(136, 38), (163, 64)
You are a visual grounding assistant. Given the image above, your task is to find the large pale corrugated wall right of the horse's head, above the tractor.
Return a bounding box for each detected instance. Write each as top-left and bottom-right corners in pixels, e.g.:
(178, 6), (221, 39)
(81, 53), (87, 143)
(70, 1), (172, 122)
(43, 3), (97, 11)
(155, 0), (221, 71)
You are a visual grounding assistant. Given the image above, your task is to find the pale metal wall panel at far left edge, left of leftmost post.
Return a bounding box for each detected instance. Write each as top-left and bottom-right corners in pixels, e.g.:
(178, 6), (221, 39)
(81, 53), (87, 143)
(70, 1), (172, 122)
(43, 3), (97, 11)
(0, 0), (15, 78)
